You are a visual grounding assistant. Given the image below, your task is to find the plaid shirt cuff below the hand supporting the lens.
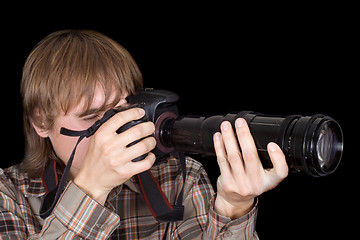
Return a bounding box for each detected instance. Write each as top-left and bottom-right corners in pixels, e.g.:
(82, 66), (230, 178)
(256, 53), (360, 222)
(207, 198), (258, 239)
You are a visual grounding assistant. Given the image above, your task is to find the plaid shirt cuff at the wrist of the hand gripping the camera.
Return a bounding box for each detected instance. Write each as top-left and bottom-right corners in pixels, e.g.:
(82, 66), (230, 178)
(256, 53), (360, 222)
(53, 182), (120, 239)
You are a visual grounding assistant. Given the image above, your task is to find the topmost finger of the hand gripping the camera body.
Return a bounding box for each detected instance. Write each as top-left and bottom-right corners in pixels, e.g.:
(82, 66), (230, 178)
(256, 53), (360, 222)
(99, 108), (145, 134)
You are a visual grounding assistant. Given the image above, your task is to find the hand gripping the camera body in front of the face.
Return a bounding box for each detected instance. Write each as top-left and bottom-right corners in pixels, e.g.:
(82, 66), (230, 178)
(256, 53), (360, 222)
(74, 108), (156, 204)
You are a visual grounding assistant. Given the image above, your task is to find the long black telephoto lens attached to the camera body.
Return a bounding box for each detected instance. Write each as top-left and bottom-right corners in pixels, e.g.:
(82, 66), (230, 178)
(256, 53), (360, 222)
(160, 111), (343, 177)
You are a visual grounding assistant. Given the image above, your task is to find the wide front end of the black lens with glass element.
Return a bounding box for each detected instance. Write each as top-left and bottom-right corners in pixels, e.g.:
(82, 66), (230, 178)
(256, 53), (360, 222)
(270, 115), (343, 177)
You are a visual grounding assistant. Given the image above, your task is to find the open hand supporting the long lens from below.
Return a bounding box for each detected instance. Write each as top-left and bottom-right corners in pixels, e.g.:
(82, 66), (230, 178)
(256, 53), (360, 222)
(214, 118), (288, 219)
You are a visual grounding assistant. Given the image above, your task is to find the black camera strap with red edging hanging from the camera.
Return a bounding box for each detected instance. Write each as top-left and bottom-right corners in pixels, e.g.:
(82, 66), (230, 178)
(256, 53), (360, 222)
(40, 114), (186, 222)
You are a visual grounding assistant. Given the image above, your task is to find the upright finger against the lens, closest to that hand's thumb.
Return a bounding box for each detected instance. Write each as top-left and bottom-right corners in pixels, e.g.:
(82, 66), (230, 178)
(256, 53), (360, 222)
(235, 118), (262, 172)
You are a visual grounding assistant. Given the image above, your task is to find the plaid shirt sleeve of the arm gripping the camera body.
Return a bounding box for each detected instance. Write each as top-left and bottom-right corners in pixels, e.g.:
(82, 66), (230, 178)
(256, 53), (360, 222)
(0, 179), (120, 239)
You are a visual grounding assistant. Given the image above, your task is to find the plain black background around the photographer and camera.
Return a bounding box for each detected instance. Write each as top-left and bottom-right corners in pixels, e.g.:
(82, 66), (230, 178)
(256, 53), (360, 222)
(1, 5), (359, 239)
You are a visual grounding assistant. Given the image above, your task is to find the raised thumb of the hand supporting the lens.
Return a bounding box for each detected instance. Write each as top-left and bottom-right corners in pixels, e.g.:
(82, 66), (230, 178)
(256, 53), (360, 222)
(267, 142), (289, 181)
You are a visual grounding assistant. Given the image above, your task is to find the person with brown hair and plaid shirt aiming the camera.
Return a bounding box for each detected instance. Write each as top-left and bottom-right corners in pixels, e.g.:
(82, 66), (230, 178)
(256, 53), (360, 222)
(0, 30), (288, 239)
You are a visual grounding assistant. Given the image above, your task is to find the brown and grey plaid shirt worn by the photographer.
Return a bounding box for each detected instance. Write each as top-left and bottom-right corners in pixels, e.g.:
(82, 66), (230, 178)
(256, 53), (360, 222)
(0, 158), (257, 239)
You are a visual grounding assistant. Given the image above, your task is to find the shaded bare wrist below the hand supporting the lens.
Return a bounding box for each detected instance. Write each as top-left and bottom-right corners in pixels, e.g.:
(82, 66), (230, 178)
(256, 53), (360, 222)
(214, 195), (255, 220)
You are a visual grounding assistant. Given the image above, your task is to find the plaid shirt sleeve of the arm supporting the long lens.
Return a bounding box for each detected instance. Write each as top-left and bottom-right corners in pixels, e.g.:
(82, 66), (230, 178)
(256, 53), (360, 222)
(173, 162), (258, 240)
